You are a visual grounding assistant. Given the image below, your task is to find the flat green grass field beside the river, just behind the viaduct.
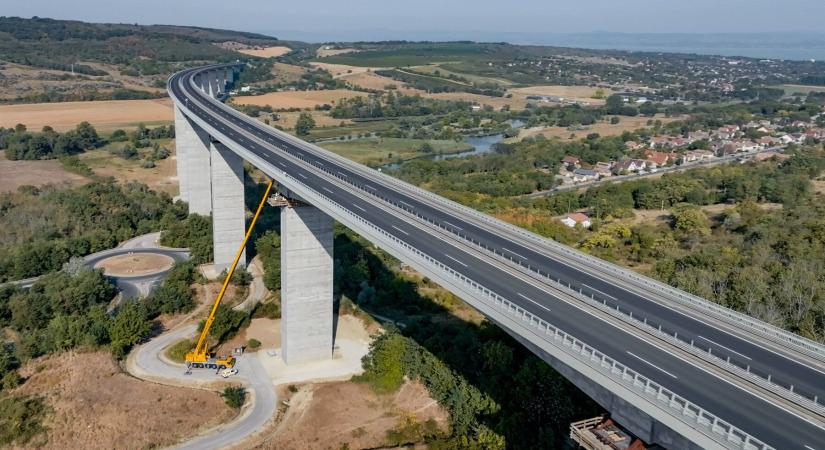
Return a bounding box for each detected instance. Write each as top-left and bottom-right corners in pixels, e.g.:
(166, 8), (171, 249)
(320, 138), (471, 165)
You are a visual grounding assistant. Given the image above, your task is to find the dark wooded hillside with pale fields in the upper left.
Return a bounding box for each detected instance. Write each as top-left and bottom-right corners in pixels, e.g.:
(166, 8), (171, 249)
(0, 17), (301, 102)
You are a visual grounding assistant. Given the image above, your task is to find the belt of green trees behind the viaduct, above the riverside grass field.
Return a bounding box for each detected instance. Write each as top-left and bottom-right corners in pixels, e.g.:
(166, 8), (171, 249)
(330, 91), (471, 119)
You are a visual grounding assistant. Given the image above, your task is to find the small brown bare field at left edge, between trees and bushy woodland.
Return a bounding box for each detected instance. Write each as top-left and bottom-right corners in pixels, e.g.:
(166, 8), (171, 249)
(0, 151), (89, 192)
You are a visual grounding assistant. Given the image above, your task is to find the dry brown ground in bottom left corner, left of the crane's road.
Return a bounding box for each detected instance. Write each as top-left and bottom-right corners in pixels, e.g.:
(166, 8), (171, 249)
(14, 351), (235, 449)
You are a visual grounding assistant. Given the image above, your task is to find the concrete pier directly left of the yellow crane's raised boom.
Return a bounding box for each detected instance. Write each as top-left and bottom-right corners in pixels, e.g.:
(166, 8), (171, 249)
(209, 142), (246, 272)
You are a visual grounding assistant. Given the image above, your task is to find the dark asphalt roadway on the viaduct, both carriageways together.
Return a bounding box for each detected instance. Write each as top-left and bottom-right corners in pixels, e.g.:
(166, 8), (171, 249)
(170, 65), (825, 450)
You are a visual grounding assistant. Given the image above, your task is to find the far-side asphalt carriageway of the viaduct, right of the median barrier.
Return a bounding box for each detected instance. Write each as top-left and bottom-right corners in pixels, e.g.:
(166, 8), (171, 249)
(174, 65), (825, 398)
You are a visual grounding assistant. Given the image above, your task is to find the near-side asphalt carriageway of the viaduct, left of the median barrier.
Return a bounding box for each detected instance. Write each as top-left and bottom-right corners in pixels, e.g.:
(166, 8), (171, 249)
(172, 67), (825, 448)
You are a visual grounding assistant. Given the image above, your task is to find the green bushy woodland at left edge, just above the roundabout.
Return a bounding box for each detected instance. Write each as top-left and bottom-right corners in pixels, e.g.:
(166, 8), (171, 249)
(0, 180), (186, 281)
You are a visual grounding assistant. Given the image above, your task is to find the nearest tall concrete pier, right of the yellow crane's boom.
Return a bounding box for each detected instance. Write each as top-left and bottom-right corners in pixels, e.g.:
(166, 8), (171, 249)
(281, 206), (333, 364)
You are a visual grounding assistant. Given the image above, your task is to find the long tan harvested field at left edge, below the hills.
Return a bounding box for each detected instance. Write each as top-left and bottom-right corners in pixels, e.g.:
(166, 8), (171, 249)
(0, 98), (173, 131)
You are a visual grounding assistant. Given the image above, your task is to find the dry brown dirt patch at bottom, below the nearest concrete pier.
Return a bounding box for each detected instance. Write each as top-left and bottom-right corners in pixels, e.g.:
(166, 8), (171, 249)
(263, 382), (448, 449)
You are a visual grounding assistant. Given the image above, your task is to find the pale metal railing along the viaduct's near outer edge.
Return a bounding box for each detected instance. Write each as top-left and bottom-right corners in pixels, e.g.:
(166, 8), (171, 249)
(177, 68), (774, 450)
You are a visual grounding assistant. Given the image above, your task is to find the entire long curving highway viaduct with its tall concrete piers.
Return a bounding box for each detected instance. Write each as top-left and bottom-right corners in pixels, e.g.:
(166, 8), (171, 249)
(168, 65), (825, 450)
